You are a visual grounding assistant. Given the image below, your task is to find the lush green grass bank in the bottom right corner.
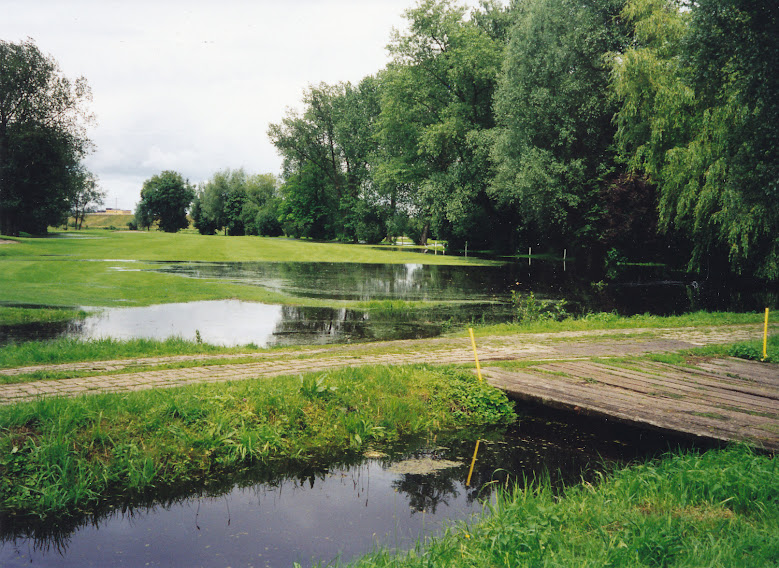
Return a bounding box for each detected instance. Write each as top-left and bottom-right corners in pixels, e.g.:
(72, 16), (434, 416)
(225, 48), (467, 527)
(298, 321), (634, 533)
(352, 447), (779, 568)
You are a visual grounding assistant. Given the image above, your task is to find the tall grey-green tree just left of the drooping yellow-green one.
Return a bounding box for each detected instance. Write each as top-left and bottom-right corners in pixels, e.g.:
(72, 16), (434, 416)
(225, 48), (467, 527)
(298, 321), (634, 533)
(491, 0), (628, 247)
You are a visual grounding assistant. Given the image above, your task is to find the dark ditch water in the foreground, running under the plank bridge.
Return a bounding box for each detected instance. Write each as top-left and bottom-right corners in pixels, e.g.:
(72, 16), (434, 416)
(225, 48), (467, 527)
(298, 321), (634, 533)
(0, 409), (708, 567)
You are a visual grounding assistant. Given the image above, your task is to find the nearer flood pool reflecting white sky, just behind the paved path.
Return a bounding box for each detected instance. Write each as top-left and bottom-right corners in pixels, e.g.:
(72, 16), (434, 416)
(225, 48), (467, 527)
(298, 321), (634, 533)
(0, 300), (510, 347)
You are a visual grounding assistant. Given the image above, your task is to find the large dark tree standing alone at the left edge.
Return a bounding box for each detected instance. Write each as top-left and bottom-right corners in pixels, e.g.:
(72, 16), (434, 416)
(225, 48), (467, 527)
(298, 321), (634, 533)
(0, 40), (91, 234)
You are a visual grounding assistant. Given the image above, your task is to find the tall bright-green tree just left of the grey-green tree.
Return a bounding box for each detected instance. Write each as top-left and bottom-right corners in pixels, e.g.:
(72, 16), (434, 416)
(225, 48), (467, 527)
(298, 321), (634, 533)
(377, 0), (508, 248)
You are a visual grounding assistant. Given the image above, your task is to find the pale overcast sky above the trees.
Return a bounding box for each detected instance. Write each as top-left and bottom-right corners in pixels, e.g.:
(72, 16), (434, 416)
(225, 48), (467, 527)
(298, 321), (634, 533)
(0, 0), (484, 209)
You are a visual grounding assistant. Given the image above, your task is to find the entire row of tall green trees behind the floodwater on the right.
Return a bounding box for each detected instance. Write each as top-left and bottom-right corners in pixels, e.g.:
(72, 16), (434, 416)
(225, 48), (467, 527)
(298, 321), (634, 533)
(268, 0), (779, 280)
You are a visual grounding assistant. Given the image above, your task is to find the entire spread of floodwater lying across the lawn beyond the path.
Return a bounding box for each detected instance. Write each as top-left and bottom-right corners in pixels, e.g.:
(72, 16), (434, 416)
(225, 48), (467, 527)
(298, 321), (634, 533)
(0, 260), (777, 347)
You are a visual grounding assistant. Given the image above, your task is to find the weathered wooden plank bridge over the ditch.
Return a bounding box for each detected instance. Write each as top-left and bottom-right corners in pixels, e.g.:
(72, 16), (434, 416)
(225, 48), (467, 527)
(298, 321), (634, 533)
(484, 359), (779, 452)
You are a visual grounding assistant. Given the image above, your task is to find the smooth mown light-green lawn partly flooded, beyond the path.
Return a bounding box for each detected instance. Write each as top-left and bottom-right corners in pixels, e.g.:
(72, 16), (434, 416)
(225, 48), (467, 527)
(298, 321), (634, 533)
(0, 230), (488, 306)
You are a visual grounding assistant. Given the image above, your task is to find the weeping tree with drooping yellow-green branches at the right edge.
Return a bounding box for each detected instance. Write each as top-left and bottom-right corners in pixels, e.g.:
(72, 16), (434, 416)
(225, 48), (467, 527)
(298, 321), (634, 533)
(614, 0), (779, 280)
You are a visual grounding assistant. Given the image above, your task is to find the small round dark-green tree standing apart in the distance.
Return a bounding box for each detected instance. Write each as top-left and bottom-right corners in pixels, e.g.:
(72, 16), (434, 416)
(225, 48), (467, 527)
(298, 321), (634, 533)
(136, 170), (195, 233)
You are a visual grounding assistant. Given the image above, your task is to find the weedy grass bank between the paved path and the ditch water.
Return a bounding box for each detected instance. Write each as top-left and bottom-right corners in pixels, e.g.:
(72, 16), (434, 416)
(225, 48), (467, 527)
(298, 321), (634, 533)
(0, 366), (513, 518)
